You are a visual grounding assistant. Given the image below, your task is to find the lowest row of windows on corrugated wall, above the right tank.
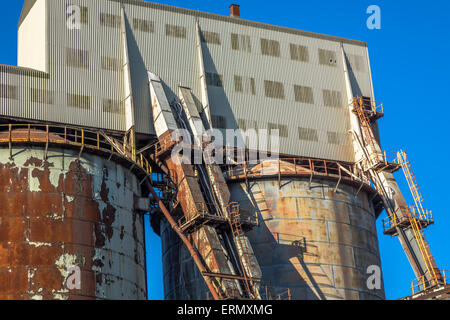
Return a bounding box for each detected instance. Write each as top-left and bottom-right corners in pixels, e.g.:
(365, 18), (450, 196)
(212, 115), (348, 145)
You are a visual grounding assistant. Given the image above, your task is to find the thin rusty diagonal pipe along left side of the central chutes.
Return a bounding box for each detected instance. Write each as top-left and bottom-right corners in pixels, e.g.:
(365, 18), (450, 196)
(147, 180), (222, 300)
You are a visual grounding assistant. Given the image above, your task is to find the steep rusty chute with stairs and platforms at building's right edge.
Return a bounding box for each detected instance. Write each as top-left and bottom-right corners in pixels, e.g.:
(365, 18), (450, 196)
(352, 97), (444, 296)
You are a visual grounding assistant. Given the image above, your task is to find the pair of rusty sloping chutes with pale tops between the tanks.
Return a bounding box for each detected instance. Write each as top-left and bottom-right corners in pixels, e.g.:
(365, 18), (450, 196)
(149, 72), (261, 300)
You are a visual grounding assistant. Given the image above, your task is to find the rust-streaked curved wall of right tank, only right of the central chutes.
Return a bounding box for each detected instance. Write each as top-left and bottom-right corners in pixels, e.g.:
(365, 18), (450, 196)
(230, 179), (384, 299)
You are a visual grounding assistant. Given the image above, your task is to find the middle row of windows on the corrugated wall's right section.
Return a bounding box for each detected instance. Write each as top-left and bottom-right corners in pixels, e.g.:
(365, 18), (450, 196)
(206, 73), (343, 108)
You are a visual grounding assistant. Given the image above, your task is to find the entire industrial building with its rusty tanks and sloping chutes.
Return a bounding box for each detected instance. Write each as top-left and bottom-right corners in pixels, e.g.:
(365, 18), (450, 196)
(0, 0), (449, 300)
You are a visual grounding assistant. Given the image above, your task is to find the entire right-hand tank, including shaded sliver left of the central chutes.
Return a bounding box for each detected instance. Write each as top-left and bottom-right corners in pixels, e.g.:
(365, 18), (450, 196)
(160, 161), (385, 300)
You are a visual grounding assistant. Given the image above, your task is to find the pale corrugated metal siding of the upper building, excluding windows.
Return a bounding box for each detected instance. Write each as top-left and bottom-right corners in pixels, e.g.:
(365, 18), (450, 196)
(0, 0), (371, 161)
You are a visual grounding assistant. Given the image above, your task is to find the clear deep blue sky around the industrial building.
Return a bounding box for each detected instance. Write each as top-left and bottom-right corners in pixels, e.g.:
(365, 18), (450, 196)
(0, 0), (450, 299)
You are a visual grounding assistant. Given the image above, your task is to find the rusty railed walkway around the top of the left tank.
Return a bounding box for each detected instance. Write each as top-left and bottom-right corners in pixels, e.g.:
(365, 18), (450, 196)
(0, 124), (152, 177)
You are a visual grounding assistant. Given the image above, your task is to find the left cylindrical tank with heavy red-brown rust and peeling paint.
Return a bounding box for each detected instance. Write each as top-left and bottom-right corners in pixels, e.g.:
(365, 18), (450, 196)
(0, 146), (147, 299)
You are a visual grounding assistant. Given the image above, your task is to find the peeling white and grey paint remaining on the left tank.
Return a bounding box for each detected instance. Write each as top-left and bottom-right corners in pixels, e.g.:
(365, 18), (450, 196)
(0, 148), (145, 300)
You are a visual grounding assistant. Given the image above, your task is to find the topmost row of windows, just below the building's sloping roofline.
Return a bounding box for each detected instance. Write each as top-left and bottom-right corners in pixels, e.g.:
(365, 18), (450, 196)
(71, 7), (366, 71)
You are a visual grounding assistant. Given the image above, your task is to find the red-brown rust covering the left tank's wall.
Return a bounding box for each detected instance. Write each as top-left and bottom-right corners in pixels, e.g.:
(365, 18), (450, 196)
(0, 148), (145, 299)
